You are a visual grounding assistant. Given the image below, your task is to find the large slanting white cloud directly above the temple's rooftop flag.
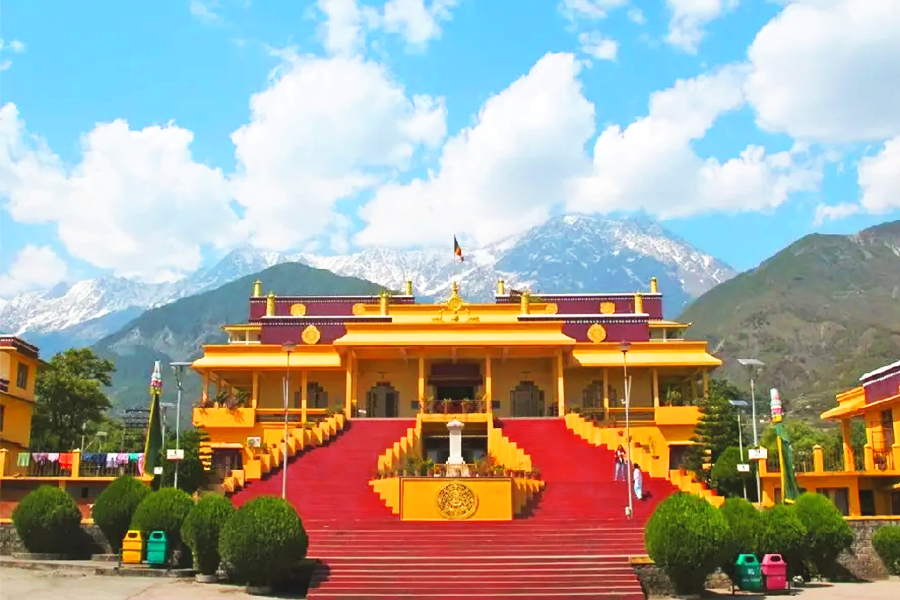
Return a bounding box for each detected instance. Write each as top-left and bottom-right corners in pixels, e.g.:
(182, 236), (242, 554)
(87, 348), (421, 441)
(355, 54), (594, 246)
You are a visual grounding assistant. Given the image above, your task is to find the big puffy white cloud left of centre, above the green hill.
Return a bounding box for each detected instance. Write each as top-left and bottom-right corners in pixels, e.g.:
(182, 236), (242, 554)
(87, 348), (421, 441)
(232, 57), (446, 250)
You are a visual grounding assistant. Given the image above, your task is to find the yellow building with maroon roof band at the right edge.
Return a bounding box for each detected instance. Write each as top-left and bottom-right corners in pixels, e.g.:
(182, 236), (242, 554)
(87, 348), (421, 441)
(762, 361), (900, 517)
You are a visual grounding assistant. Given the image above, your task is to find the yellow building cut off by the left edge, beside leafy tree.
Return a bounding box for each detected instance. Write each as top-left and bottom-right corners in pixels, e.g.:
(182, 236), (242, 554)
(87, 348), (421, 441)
(0, 336), (40, 464)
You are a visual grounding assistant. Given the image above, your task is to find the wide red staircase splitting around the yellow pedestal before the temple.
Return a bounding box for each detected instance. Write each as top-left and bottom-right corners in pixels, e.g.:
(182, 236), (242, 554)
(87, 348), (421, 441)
(233, 418), (673, 600)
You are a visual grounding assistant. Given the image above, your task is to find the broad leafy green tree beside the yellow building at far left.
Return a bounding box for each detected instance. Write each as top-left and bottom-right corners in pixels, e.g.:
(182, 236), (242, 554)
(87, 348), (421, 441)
(31, 348), (116, 450)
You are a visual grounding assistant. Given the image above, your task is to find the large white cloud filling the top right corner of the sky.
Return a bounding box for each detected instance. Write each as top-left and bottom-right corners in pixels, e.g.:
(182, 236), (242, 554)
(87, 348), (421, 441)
(747, 0), (900, 142)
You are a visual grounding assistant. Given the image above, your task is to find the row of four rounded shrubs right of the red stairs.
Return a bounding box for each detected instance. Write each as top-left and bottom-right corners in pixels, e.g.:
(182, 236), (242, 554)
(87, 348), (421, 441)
(645, 493), (856, 594)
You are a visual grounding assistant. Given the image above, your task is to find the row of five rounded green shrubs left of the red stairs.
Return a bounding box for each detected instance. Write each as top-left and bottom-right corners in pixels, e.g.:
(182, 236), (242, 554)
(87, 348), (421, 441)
(12, 476), (309, 586)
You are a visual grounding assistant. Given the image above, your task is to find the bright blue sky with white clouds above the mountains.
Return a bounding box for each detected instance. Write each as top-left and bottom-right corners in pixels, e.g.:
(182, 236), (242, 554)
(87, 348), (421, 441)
(0, 0), (900, 295)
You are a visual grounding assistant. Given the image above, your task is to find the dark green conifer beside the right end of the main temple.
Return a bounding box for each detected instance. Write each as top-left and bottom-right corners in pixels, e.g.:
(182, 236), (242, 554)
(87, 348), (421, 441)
(685, 380), (741, 481)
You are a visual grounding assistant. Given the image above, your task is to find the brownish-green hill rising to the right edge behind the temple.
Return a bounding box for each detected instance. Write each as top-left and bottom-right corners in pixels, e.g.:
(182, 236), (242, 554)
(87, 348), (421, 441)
(679, 221), (900, 420)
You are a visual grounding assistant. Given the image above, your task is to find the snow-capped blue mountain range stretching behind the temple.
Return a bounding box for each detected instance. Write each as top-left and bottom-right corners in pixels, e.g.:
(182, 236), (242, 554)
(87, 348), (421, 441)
(0, 215), (735, 354)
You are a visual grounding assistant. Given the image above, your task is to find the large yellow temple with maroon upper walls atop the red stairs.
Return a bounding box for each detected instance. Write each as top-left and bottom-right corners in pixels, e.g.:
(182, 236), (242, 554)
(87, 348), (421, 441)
(193, 278), (721, 510)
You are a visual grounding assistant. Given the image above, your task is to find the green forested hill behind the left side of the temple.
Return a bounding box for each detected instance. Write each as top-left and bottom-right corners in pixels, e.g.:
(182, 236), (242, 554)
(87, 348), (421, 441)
(93, 263), (383, 408)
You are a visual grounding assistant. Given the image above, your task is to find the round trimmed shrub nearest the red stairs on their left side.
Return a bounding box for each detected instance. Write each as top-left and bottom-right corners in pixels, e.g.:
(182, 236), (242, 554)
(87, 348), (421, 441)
(219, 496), (309, 586)
